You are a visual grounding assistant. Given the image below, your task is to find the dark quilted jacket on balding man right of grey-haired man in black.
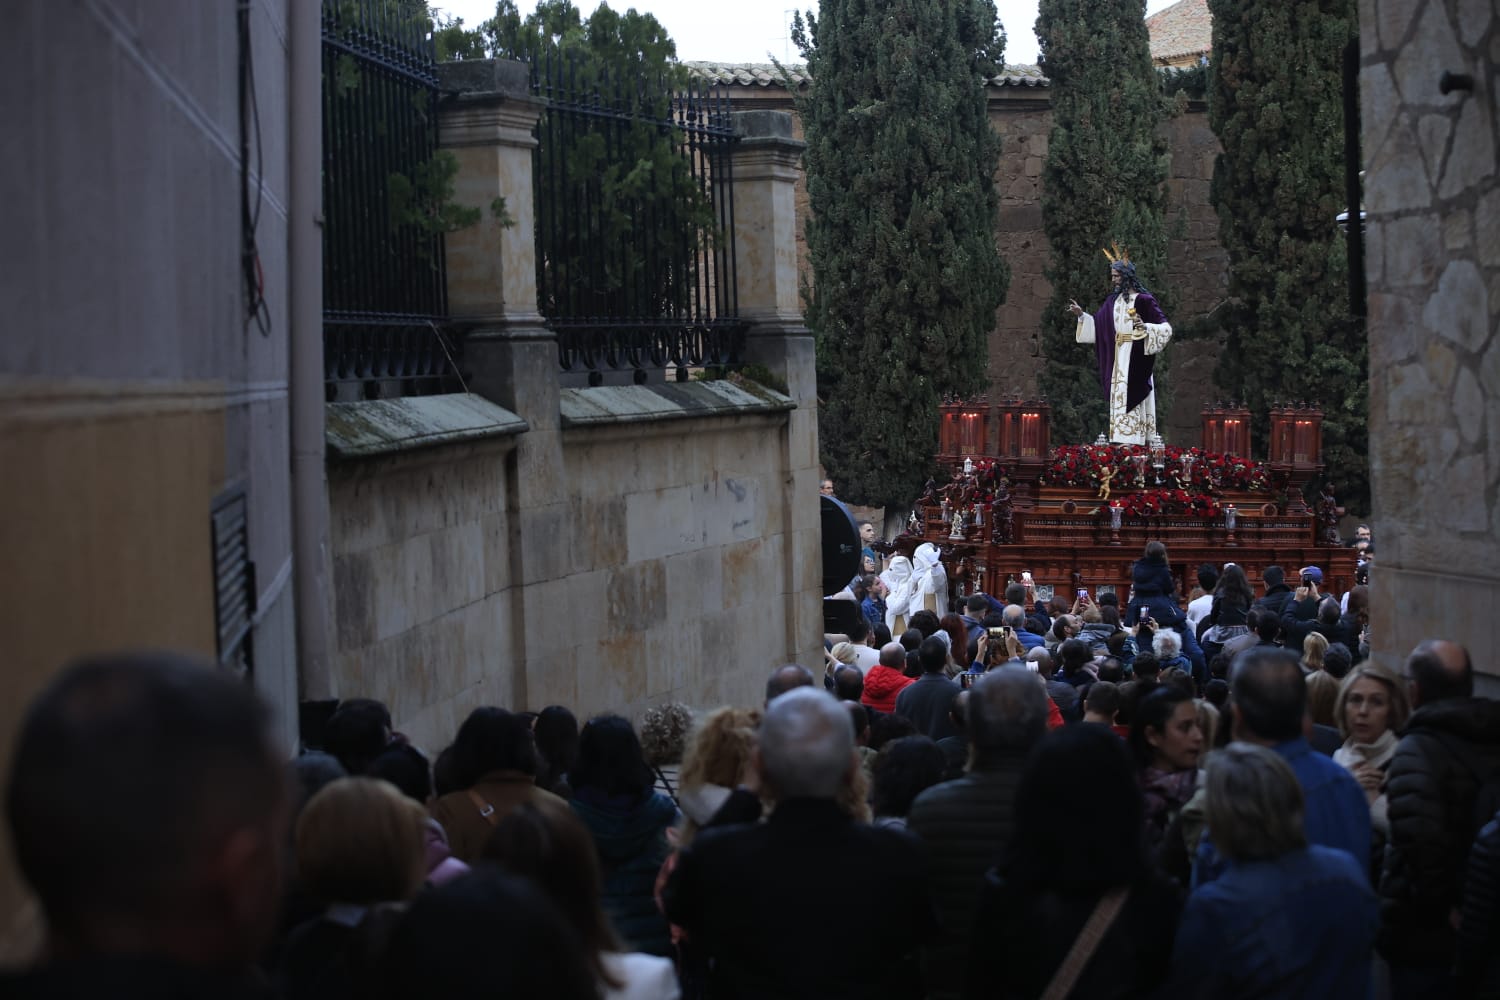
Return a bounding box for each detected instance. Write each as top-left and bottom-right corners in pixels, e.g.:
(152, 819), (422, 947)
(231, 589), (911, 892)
(906, 753), (1026, 997)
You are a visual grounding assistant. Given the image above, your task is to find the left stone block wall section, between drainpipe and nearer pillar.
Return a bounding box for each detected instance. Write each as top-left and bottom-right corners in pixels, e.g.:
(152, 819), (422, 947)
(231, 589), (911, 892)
(329, 441), (522, 751)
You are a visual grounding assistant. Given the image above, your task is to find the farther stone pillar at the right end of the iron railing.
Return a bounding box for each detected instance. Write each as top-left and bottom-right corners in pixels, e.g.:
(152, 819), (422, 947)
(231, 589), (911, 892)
(732, 111), (824, 673)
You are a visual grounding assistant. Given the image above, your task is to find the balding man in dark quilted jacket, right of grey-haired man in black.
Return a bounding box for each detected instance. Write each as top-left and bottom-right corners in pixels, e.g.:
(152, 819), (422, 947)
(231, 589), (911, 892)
(890, 666), (1047, 999)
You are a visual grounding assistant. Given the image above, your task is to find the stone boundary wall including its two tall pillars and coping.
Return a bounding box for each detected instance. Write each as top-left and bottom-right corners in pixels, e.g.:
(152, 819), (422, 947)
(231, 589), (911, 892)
(319, 76), (822, 750)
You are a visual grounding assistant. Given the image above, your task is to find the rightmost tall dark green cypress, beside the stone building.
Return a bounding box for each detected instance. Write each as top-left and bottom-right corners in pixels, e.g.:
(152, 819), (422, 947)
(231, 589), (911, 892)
(1209, 0), (1370, 507)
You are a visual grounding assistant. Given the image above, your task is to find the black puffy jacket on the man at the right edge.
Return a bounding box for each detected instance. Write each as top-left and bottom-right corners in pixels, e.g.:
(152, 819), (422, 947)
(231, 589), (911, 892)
(1380, 699), (1500, 964)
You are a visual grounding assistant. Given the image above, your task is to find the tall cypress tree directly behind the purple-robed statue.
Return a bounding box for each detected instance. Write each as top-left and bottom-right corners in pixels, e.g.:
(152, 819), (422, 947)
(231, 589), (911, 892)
(1037, 0), (1176, 444)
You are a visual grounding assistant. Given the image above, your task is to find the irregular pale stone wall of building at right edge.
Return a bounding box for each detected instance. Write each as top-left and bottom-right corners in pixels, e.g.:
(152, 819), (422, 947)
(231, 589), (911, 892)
(1359, 0), (1500, 688)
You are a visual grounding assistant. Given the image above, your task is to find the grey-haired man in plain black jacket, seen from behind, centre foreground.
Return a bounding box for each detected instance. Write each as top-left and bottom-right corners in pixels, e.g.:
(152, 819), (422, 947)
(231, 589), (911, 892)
(665, 688), (938, 1000)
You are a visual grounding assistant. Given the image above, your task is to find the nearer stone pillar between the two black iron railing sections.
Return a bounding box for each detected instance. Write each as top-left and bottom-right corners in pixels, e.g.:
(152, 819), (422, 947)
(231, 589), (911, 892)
(438, 60), (567, 705)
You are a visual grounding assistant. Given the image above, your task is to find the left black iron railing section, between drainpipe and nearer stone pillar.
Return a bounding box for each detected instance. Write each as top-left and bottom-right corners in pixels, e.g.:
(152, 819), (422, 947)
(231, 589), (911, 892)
(323, 0), (461, 400)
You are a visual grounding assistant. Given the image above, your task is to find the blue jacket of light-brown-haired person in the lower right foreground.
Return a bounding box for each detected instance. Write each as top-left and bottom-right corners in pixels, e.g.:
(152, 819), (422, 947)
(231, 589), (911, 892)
(1163, 845), (1380, 1000)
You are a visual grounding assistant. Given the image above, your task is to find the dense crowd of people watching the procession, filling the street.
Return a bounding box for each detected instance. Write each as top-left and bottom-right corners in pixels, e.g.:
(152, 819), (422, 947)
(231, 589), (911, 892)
(0, 527), (1500, 1000)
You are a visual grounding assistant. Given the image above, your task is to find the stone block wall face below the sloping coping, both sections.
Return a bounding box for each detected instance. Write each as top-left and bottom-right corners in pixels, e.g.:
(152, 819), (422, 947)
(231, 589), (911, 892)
(329, 387), (821, 751)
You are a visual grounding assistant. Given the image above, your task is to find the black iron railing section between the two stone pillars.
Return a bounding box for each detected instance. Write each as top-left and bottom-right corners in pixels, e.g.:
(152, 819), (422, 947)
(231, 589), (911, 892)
(531, 52), (746, 385)
